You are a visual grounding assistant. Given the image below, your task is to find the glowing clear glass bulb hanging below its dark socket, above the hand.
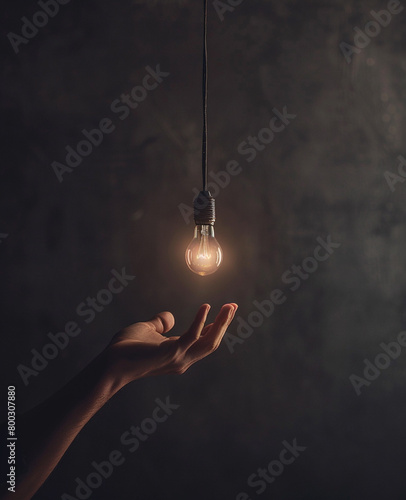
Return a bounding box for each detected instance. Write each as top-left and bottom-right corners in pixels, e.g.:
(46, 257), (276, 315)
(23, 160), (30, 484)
(185, 224), (223, 276)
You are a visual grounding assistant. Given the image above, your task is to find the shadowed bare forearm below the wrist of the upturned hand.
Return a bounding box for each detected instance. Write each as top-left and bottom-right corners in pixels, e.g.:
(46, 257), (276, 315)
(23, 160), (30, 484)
(3, 355), (122, 500)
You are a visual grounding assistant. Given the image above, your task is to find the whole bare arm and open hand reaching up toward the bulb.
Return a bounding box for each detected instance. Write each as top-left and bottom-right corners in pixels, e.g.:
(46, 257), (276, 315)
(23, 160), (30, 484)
(1, 303), (238, 500)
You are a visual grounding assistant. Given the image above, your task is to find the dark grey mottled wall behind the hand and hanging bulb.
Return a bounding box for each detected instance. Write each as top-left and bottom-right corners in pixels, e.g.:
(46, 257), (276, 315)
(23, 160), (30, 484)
(0, 0), (406, 500)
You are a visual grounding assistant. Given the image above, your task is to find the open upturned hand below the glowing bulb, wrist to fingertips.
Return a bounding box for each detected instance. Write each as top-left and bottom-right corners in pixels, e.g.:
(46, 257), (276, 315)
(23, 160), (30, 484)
(106, 303), (238, 388)
